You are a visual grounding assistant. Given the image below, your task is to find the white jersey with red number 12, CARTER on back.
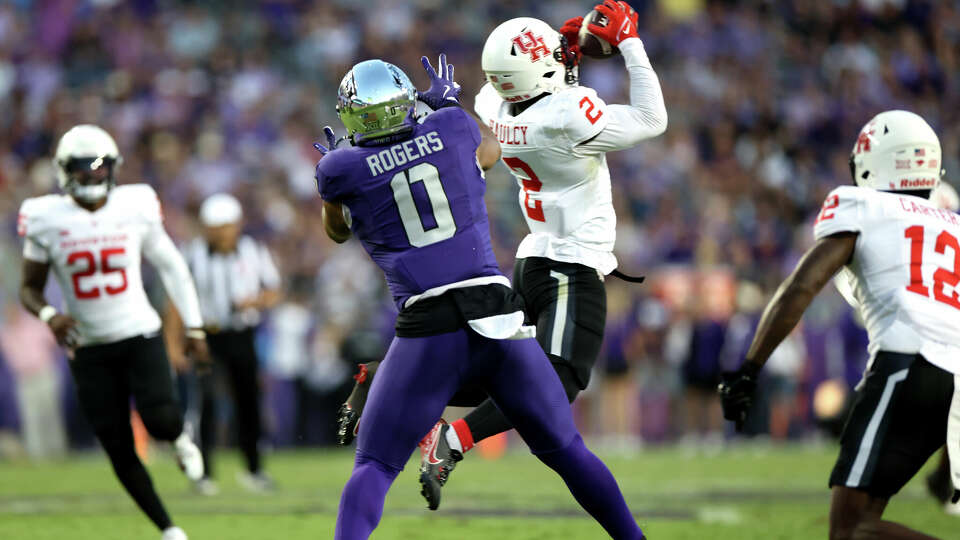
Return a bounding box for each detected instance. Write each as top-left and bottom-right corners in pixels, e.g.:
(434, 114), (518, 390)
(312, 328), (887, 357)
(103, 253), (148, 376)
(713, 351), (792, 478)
(814, 186), (960, 374)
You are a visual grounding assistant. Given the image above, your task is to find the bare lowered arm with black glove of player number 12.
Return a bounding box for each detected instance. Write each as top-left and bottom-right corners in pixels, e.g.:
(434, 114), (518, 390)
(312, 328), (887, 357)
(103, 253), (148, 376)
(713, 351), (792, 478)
(717, 232), (858, 431)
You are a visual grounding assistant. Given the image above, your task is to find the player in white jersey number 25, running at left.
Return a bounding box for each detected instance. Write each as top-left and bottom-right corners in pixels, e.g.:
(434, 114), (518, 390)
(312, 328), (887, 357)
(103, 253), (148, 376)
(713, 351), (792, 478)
(18, 124), (209, 540)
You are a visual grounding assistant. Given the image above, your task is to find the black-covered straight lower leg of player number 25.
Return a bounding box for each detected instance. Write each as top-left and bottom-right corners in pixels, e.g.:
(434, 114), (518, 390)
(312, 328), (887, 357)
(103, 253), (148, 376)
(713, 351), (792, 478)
(100, 426), (172, 531)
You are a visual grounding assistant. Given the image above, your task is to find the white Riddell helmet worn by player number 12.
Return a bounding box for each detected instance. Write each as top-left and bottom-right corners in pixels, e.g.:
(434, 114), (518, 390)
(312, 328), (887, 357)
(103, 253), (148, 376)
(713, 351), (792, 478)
(850, 111), (943, 191)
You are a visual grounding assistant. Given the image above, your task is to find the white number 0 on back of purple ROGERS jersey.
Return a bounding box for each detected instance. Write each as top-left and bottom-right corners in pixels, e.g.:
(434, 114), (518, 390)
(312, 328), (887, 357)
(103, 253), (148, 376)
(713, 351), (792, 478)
(390, 163), (457, 247)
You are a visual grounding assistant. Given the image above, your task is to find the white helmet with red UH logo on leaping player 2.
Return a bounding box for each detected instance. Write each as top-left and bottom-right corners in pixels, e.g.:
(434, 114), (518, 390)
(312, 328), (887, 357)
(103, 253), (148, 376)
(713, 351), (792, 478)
(481, 17), (577, 103)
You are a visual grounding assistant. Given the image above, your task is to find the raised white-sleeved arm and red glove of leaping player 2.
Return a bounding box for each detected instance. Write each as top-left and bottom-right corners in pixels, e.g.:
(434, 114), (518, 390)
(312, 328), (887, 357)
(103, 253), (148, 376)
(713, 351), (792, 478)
(581, 0), (667, 152)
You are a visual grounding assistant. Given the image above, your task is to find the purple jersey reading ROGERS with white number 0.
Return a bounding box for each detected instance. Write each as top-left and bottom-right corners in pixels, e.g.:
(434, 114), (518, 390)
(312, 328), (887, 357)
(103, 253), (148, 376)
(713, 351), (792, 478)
(317, 107), (500, 308)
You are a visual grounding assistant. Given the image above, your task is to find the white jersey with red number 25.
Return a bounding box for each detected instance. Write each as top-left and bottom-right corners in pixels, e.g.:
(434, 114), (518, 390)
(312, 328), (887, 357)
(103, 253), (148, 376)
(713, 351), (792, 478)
(18, 184), (201, 346)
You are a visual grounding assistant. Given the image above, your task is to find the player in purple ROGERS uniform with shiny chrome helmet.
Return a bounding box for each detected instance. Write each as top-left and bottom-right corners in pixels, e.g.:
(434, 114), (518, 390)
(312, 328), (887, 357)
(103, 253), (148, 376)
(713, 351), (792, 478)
(317, 55), (643, 540)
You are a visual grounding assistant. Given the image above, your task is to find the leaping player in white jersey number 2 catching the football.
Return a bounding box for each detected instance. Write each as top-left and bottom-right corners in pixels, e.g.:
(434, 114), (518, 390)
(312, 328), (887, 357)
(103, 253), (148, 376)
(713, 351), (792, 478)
(339, 1), (667, 509)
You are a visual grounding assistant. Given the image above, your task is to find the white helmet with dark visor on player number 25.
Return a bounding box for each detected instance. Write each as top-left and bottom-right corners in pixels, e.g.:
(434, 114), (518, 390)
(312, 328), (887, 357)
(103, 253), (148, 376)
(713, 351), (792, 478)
(53, 124), (123, 202)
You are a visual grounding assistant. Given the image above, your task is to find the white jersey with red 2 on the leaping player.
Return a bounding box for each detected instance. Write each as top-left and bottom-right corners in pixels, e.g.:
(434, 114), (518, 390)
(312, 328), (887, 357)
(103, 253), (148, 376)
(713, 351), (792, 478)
(475, 38), (666, 274)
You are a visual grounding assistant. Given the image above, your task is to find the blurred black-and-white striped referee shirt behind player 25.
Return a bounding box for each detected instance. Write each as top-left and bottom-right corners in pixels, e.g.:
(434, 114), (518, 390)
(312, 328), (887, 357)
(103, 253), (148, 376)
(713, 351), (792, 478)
(184, 236), (280, 330)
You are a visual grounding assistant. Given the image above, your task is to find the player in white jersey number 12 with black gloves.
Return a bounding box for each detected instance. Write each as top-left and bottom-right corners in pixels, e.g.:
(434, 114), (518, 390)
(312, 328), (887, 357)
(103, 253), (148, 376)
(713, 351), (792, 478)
(720, 111), (960, 540)
